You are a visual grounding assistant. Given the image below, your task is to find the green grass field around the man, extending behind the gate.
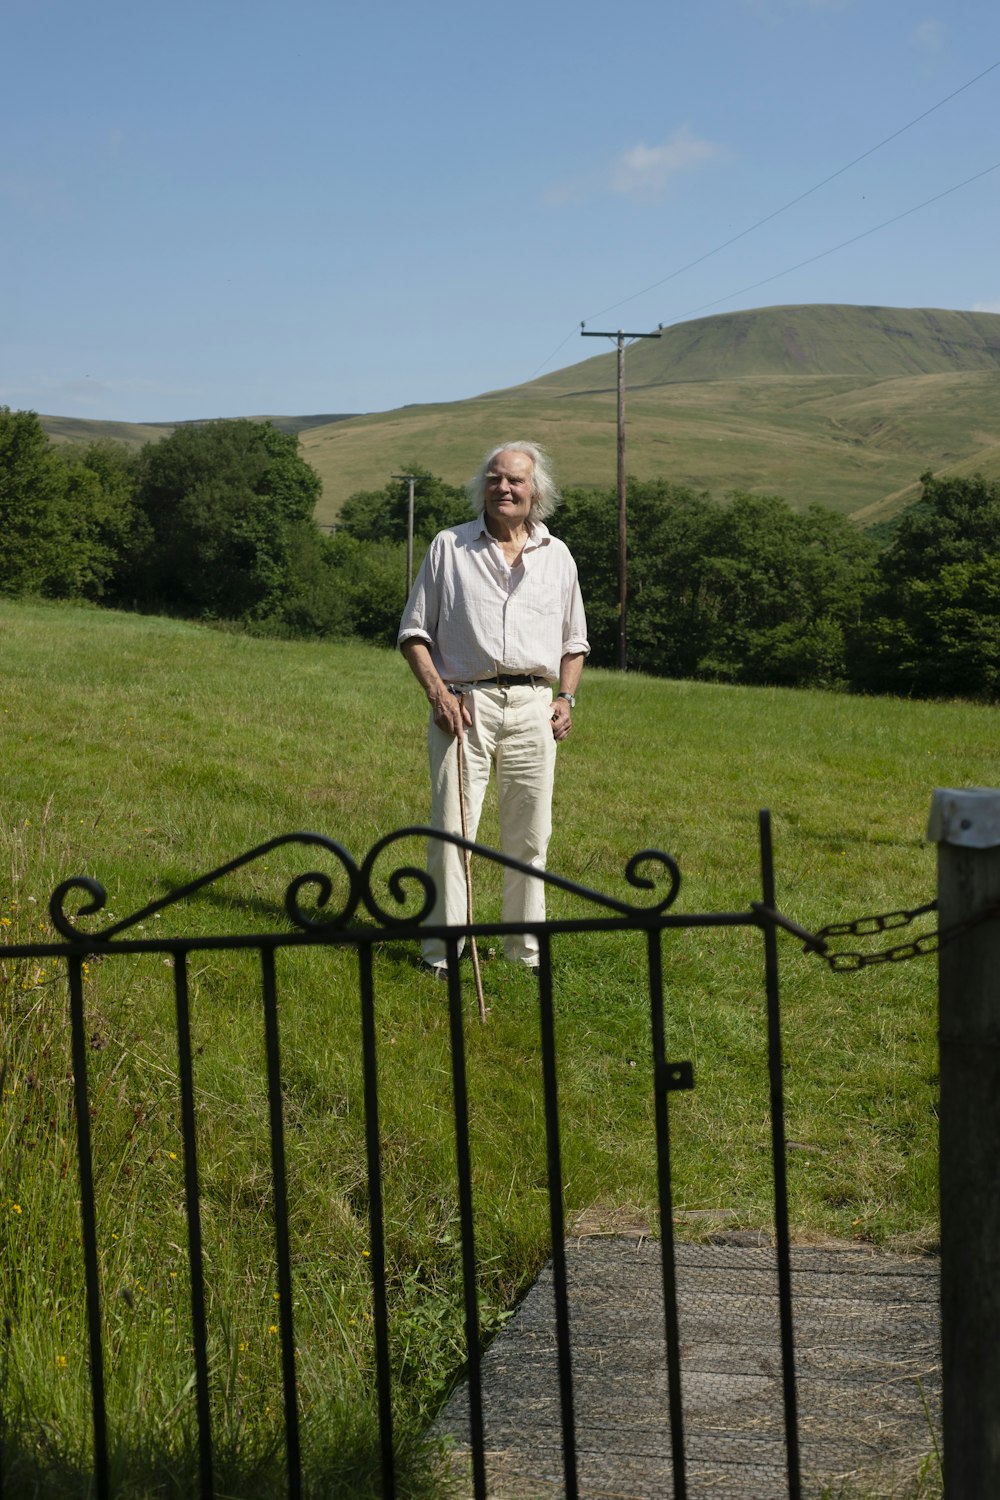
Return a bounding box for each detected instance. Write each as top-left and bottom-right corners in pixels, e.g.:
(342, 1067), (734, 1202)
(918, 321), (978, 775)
(0, 602), (1000, 1497)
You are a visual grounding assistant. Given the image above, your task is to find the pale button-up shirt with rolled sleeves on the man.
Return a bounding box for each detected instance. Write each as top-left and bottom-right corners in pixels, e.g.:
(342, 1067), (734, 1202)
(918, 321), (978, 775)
(399, 515), (591, 683)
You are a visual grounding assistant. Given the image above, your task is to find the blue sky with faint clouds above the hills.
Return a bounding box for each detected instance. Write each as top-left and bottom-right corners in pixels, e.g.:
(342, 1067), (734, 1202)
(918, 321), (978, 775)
(0, 0), (1000, 422)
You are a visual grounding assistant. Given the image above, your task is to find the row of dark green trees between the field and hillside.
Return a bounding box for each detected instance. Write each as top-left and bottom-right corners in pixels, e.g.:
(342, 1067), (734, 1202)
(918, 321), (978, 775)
(0, 408), (1000, 702)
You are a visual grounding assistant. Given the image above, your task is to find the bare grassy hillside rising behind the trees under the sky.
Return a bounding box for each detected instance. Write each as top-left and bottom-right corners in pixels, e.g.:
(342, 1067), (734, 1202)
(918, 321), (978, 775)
(31, 305), (1000, 524)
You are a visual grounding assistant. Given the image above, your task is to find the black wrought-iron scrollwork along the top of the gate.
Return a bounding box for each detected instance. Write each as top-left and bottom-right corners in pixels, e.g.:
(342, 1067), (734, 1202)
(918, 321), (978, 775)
(48, 825), (681, 944)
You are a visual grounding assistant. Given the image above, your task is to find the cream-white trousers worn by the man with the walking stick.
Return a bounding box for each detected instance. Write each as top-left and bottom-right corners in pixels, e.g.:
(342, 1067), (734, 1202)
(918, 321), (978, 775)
(421, 684), (556, 966)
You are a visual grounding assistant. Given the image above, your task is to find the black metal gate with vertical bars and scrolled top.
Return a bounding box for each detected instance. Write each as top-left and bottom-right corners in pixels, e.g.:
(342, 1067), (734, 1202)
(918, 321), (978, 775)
(0, 813), (801, 1500)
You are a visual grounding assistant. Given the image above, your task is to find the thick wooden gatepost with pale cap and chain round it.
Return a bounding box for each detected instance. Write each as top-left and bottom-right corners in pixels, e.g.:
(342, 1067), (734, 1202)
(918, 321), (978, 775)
(928, 788), (1000, 1500)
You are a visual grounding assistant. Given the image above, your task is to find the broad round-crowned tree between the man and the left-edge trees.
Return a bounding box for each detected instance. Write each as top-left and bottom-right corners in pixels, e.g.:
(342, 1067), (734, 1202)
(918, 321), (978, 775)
(132, 420), (321, 621)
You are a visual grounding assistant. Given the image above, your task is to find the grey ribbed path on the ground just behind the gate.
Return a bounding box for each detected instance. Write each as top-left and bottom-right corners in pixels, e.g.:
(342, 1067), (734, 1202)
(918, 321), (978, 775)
(439, 1236), (940, 1500)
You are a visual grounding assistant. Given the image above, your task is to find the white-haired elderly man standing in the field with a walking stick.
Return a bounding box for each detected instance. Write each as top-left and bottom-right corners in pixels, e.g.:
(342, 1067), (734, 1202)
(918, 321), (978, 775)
(399, 443), (589, 978)
